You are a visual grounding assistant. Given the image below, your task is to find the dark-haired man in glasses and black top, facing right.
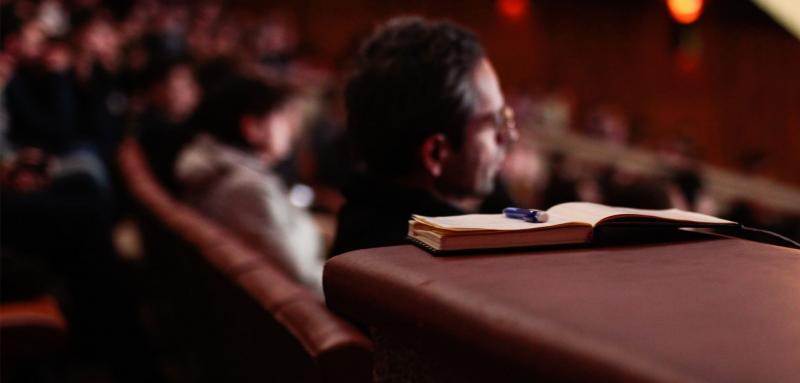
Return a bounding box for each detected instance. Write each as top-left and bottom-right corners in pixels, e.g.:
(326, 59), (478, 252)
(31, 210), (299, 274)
(332, 18), (517, 255)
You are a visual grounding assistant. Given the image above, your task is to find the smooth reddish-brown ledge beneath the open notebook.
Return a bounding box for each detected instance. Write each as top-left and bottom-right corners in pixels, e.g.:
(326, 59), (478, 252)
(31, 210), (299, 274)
(325, 239), (800, 382)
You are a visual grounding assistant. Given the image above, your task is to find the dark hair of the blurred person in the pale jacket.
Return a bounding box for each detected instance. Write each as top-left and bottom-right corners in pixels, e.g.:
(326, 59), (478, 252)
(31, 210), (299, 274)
(192, 75), (291, 149)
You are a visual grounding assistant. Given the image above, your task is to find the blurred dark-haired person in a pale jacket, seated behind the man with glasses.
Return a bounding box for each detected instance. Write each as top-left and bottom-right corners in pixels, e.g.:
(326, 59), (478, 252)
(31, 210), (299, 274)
(175, 78), (324, 296)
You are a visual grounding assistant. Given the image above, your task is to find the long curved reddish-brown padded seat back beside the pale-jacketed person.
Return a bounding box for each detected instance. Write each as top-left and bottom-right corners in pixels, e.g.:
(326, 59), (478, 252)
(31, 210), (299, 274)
(118, 138), (372, 382)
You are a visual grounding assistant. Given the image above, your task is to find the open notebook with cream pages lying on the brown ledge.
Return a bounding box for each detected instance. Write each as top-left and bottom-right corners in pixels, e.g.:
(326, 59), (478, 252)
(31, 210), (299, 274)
(408, 202), (738, 252)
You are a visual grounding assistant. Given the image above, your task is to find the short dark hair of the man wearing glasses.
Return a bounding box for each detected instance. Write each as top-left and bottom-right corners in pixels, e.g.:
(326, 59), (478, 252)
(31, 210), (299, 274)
(346, 17), (484, 176)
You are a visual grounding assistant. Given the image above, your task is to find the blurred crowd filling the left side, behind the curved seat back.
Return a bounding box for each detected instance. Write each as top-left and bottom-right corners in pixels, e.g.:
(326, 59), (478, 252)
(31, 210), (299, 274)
(0, 0), (344, 381)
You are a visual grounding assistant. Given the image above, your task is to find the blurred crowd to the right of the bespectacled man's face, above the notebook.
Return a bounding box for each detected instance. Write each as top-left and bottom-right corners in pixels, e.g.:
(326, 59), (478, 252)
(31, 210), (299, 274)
(504, 92), (800, 240)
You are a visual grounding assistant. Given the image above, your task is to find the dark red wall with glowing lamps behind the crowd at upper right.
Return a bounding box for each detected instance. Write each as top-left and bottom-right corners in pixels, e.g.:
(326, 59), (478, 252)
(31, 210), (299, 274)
(255, 0), (800, 186)
